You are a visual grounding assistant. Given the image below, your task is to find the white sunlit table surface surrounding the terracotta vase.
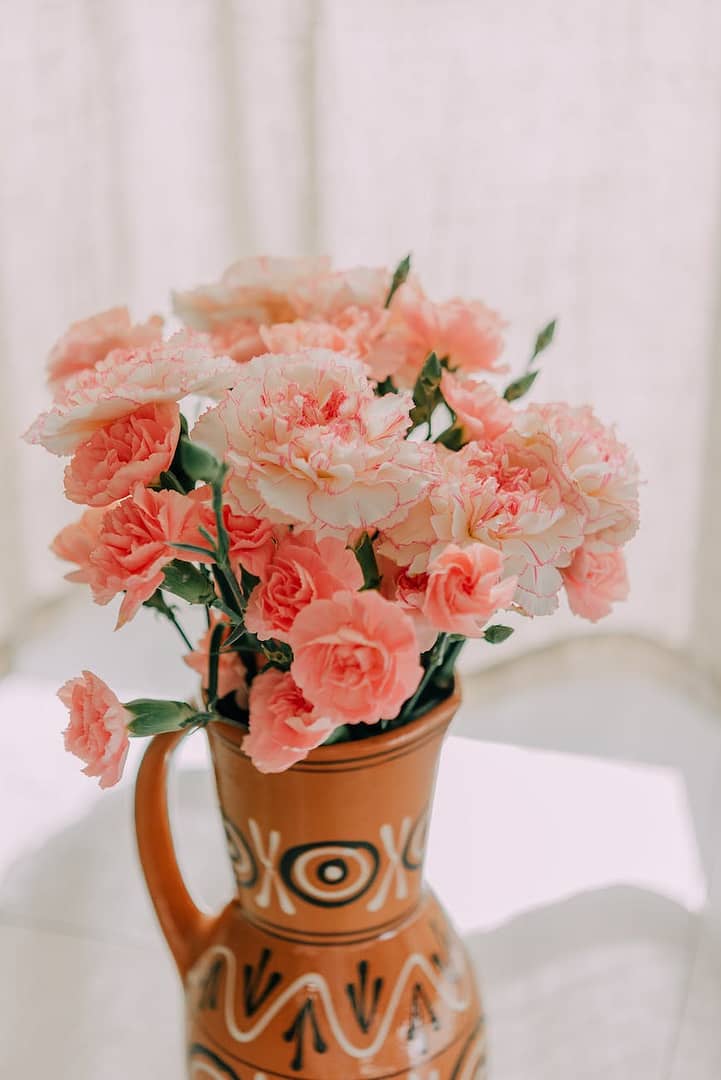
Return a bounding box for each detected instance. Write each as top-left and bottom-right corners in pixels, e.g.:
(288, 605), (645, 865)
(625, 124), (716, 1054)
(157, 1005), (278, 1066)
(0, 652), (721, 1080)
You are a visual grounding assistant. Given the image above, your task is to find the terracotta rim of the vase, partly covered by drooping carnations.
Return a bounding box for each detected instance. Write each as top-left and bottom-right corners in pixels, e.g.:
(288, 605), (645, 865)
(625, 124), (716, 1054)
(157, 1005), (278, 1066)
(213, 675), (461, 772)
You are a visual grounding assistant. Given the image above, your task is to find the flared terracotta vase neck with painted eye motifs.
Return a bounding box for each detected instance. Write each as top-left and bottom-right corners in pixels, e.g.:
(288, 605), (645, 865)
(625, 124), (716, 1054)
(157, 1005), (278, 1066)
(209, 701), (455, 942)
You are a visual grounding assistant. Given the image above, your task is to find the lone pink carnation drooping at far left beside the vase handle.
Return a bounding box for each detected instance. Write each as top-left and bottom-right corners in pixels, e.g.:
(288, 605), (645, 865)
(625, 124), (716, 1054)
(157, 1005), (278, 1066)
(57, 671), (132, 787)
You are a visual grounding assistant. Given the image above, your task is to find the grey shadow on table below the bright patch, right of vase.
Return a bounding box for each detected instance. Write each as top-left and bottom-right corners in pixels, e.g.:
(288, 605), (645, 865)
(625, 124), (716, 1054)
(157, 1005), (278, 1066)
(466, 886), (699, 1080)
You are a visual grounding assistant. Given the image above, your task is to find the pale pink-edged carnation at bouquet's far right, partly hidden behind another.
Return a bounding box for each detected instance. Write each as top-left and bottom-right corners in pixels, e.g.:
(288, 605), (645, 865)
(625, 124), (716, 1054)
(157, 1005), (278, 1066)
(517, 402), (639, 552)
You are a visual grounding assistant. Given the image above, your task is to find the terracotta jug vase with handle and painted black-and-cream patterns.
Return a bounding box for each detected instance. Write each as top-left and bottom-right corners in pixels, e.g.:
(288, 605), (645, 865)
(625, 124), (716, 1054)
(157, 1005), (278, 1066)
(136, 697), (486, 1080)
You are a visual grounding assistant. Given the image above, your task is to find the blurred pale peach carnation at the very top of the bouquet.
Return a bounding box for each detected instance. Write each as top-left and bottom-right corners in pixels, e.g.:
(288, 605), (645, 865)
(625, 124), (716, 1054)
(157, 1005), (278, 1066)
(173, 256), (330, 332)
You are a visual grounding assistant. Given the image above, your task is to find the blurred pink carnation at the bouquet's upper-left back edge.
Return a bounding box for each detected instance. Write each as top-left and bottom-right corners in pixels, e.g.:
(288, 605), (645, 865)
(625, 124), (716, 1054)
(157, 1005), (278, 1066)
(47, 308), (163, 387)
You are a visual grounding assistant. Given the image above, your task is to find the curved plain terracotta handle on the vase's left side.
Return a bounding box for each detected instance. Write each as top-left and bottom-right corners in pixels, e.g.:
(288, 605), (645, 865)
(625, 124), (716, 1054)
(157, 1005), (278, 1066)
(135, 731), (215, 980)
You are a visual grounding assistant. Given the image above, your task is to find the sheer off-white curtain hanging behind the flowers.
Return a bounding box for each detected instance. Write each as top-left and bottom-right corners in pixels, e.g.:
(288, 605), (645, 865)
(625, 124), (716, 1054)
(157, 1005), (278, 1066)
(0, 0), (721, 677)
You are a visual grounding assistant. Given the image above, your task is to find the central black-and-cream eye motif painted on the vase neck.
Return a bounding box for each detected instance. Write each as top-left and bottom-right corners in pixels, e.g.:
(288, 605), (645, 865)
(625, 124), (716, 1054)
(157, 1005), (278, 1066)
(281, 840), (379, 907)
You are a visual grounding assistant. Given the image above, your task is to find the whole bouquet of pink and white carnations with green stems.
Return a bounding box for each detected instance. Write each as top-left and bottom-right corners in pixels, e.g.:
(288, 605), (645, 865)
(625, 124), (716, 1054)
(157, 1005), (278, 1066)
(27, 259), (638, 786)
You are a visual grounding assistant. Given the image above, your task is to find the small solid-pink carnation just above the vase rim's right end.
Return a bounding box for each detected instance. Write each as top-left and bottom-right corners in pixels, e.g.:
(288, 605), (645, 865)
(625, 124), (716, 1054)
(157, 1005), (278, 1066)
(423, 543), (516, 637)
